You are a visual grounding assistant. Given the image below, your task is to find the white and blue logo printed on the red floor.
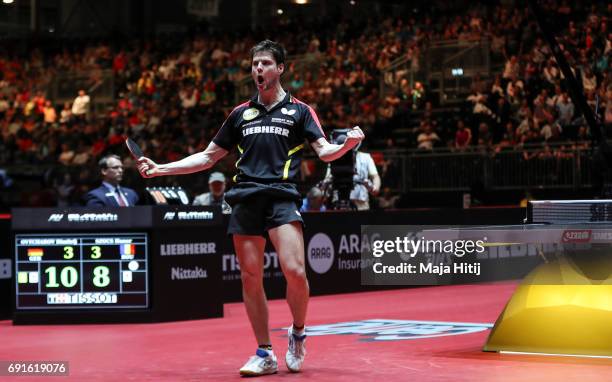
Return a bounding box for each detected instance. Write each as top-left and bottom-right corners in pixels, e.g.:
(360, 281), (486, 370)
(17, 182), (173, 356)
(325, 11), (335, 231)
(292, 319), (493, 341)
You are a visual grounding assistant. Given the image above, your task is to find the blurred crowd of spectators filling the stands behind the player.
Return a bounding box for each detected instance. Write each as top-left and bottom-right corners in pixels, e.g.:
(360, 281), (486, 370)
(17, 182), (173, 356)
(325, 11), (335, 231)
(0, 0), (612, 207)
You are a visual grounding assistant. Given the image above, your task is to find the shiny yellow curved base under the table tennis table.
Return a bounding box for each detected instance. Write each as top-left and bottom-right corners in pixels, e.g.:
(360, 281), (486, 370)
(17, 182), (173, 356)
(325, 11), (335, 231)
(483, 254), (612, 357)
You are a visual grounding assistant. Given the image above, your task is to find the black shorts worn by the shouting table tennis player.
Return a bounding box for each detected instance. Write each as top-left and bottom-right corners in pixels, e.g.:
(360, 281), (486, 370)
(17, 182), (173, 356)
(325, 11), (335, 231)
(227, 194), (304, 236)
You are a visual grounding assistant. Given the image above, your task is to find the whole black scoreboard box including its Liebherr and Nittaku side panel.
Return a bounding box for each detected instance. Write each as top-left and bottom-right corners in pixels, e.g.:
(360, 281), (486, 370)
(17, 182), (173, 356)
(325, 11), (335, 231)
(9, 205), (227, 325)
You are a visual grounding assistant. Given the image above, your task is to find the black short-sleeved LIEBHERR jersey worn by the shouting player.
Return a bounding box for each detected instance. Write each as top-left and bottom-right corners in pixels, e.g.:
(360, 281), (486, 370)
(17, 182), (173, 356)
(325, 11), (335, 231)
(213, 93), (325, 184)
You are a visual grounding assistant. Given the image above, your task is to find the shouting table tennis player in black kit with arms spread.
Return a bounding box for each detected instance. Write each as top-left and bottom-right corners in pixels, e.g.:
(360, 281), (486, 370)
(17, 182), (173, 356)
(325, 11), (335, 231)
(138, 40), (364, 375)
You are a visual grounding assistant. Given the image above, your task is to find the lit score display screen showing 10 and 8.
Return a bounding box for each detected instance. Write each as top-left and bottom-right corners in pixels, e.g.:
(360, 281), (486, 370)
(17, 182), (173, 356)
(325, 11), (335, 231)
(15, 233), (149, 309)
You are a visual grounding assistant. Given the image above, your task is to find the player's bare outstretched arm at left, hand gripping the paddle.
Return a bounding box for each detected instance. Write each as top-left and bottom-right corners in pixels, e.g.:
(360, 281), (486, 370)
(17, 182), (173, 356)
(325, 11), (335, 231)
(138, 142), (227, 178)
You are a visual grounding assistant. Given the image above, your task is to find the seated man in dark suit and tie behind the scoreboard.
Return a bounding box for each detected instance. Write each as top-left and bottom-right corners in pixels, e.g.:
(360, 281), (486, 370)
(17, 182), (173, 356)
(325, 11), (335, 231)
(85, 155), (138, 207)
